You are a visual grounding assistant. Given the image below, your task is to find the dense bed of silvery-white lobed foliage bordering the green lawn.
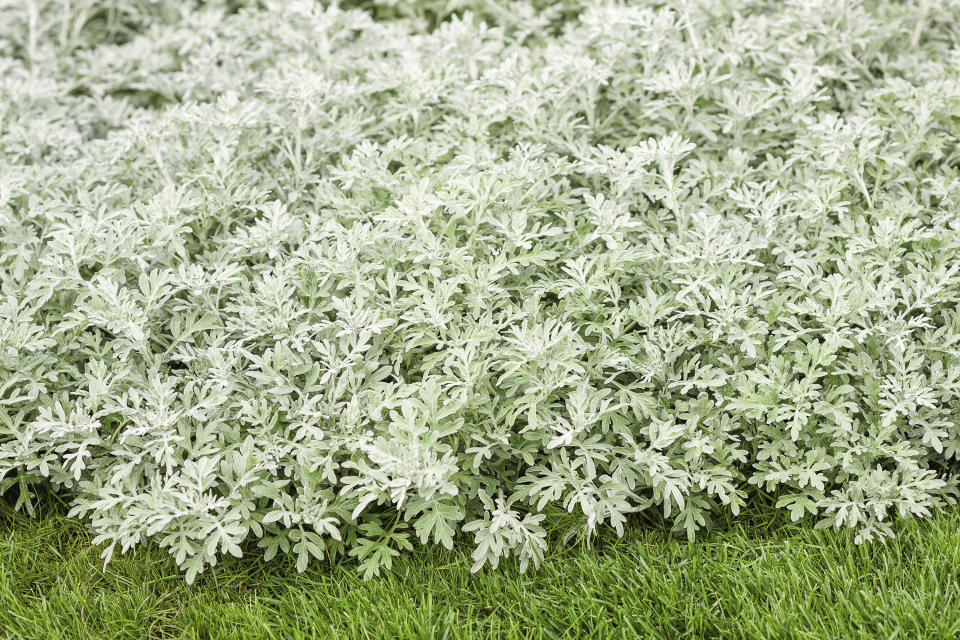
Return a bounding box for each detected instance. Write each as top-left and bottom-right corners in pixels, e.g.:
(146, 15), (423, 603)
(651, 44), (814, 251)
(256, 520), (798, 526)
(0, 0), (960, 580)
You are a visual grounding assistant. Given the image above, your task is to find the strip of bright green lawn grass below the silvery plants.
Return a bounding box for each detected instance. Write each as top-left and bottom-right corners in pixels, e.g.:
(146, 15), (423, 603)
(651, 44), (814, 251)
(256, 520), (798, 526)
(0, 500), (960, 640)
